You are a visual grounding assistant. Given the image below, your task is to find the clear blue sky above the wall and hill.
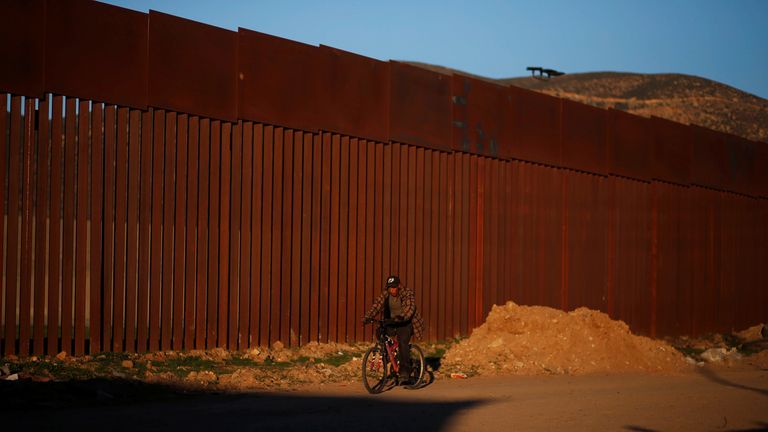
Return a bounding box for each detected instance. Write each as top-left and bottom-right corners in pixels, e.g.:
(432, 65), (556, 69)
(104, 0), (768, 98)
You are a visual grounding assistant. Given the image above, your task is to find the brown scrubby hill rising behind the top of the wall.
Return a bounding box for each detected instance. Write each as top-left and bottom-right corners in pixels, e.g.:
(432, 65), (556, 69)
(410, 62), (768, 142)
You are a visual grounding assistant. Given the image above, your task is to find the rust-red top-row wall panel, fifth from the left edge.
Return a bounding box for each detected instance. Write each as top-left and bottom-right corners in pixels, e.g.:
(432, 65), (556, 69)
(317, 45), (389, 142)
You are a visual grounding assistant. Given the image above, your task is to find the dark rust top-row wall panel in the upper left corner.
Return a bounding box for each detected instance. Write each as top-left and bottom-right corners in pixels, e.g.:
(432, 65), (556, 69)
(0, 0), (44, 97)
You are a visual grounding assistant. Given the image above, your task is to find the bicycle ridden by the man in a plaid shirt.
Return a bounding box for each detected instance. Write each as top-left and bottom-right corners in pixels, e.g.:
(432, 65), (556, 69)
(362, 319), (424, 394)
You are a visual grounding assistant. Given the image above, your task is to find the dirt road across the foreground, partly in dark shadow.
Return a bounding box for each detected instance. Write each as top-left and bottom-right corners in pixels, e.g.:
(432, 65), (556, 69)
(6, 368), (768, 432)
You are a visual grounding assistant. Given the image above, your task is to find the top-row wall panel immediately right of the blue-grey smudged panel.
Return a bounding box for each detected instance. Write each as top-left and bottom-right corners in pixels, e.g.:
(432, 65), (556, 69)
(502, 86), (562, 166)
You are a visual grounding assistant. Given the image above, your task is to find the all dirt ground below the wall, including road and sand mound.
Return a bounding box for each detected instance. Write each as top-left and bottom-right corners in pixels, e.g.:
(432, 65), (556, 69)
(0, 302), (768, 431)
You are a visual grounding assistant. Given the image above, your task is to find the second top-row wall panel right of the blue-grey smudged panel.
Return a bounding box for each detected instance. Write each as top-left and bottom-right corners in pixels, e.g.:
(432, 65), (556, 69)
(550, 99), (608, 174)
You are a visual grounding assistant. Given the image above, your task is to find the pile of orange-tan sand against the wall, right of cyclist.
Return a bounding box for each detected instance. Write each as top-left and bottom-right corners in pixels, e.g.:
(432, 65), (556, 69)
(443, 302), (690, 375)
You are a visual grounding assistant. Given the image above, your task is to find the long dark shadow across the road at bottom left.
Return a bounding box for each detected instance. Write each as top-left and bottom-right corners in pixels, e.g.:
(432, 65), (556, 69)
(0, 379), (483, 432)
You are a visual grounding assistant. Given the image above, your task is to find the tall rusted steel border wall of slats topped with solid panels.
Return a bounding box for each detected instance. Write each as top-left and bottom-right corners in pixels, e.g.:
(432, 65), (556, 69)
(0, 0), (768, 355)
